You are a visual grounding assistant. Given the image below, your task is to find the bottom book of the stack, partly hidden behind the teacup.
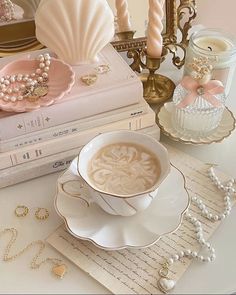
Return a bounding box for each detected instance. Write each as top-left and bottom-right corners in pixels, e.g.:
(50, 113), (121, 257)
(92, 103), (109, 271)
(0, 125), (160, 188)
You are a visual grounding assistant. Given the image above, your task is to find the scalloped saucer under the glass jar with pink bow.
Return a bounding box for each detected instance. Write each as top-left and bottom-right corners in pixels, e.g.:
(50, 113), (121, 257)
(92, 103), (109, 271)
(157, 103), (236, 145)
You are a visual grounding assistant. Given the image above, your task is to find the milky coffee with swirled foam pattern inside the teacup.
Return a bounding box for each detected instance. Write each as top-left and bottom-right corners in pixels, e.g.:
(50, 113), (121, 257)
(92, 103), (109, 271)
(88, 143), (161, 196)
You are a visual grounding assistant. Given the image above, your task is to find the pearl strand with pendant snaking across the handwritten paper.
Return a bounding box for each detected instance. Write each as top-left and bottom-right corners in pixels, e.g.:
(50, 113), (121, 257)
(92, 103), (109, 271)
(158, 167), (236, 293)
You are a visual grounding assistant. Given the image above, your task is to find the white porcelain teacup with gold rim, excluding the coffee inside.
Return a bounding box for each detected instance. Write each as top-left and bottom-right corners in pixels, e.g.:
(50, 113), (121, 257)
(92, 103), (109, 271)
(68, 131), (170, 216)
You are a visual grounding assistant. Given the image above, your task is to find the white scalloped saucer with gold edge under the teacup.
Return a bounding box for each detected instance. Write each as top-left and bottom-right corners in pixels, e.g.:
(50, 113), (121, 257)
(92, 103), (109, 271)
(55, 158), (190, 250)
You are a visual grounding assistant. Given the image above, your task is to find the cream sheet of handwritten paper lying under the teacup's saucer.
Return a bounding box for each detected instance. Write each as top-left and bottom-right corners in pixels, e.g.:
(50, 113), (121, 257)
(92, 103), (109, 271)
(47, 146), (234, 294)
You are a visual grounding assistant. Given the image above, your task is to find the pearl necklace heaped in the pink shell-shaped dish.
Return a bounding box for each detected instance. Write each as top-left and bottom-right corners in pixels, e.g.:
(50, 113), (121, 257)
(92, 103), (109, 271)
(0, 53), (51, 102)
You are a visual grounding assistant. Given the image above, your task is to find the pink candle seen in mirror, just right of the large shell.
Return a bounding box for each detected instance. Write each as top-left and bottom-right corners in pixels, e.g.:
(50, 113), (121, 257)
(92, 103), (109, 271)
(116, 0), (131, 32)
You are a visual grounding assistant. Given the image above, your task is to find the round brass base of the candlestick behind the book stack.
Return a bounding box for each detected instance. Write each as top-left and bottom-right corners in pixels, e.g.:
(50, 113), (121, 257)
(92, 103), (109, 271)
(140, 74), (176, 104)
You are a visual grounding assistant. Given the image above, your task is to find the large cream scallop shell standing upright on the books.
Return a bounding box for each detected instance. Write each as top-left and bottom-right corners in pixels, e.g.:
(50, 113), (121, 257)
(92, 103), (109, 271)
(35, 0), (114, 65)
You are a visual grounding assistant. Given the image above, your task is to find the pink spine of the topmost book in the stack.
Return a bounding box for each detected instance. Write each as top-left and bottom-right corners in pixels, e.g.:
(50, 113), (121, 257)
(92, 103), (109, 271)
(0, 83), (142, 141)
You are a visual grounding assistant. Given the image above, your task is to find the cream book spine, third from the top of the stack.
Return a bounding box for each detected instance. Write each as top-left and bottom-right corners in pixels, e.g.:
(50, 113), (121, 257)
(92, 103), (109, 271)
(0, 109), (155, 169)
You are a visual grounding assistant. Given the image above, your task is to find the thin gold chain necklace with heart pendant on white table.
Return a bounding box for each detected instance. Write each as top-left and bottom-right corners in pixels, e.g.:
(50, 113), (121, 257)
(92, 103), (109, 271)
(0, 228), (67, 279)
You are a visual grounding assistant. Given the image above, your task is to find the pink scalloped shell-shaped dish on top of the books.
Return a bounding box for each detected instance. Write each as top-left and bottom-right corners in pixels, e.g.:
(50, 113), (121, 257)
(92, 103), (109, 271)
(0, 58), (75, 113)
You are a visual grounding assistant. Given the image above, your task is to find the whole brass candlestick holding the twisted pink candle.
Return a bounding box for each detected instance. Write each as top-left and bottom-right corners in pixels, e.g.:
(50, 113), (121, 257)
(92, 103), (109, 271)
(140, 48), (175, 104)
